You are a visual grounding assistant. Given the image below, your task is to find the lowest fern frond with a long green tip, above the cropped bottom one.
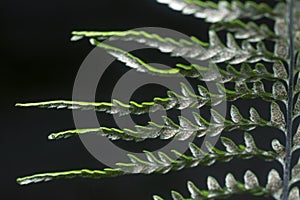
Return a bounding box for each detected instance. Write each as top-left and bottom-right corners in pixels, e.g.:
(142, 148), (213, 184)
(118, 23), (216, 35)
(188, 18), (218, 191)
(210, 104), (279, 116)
(17, 133), (278, 184)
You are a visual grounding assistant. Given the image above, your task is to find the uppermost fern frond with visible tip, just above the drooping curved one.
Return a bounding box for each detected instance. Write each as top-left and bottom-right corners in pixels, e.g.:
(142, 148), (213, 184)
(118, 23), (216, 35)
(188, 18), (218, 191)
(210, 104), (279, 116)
(73, 31), (281, 64)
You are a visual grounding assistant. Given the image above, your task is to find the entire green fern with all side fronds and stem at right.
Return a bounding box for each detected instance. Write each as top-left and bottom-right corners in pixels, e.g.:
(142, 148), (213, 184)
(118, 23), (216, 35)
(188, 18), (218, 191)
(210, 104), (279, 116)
(17, 0), (300, 200)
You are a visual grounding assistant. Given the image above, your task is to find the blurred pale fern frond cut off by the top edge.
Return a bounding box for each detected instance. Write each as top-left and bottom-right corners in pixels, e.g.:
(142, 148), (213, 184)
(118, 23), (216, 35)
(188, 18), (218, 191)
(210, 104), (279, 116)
(157, 0), (282, 23)
